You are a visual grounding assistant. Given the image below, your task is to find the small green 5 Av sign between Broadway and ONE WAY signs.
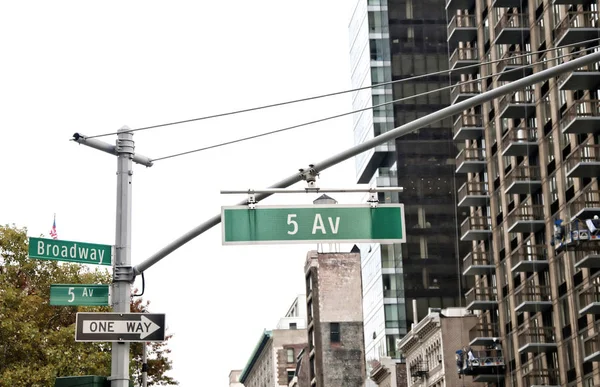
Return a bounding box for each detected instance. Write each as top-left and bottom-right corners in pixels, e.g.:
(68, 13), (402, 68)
(50, 284), (109, 306)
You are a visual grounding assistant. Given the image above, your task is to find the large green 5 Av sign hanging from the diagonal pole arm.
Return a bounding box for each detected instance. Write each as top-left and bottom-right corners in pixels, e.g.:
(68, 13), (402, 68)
(221, 204), (406, 245)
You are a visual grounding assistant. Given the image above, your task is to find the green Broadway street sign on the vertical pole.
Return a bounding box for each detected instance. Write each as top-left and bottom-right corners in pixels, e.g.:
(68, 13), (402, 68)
(29, 237), (113, 266)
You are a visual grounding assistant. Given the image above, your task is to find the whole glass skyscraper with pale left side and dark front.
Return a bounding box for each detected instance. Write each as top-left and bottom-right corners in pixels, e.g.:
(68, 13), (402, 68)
(349, 0), (467, 374)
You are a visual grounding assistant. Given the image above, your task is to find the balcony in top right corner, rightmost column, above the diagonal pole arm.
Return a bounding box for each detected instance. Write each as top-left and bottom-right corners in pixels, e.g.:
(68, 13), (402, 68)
(554, 11), (598, 47)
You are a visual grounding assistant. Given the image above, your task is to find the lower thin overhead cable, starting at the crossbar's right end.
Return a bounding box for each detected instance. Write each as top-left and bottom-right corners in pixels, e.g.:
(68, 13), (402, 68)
(150, 46), (600, 162)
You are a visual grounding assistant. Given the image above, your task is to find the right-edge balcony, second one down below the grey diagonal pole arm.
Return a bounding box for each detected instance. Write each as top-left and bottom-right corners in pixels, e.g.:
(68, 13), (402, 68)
(560, 100), (600, 134)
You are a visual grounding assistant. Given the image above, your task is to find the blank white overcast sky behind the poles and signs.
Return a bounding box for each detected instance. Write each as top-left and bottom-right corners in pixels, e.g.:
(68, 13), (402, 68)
(0, 0), (362, 387)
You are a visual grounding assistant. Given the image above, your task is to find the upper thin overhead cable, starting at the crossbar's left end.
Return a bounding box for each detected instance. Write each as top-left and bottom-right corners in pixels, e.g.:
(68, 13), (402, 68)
(87, 38), (600, 138)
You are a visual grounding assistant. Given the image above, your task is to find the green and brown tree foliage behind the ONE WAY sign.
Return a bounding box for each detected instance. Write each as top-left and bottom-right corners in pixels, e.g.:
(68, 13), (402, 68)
(0, 226), (178, 387)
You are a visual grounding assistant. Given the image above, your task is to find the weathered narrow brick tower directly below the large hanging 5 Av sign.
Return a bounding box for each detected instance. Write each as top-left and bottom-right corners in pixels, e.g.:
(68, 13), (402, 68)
(301, 248), (366, 387)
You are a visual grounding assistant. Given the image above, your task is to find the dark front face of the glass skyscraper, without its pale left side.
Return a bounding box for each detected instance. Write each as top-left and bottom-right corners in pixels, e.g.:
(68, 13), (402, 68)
(388, 0), (469, 327)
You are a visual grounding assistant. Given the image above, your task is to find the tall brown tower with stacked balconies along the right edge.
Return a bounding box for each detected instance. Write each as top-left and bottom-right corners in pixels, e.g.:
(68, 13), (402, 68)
(446, 0), (600, 387)
